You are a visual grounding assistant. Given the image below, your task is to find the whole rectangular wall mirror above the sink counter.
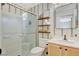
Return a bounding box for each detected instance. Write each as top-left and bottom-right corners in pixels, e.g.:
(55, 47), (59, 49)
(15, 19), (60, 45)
(55, 3), (78, 29)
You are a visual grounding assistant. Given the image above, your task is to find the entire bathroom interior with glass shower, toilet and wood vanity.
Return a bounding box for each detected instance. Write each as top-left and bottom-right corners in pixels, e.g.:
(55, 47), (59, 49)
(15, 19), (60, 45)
(0, 3), (79, 56)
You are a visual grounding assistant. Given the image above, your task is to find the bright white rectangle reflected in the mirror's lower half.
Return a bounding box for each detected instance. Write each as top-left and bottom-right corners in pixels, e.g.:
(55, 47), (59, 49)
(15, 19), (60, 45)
(59, 15), (72, 28)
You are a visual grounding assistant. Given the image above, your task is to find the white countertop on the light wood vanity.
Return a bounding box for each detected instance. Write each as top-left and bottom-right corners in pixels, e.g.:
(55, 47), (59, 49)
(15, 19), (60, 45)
(48, 39), (79, 48)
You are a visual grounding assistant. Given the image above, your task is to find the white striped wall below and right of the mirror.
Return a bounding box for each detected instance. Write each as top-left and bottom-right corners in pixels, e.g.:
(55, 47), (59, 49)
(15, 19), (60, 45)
(55, 4), (79, 36)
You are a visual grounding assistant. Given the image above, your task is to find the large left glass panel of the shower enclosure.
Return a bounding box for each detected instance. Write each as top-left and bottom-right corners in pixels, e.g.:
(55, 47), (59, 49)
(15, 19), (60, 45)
(2, 13), (22, 56)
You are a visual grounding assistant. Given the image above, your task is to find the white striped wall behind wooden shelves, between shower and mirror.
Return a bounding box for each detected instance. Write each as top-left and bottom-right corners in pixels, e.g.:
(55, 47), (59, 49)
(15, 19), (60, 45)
(28, 3), (54, 38)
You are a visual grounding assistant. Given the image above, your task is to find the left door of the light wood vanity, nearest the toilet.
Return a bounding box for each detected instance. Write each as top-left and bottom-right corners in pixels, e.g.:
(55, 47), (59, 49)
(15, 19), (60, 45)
(48, 44), (62, 56)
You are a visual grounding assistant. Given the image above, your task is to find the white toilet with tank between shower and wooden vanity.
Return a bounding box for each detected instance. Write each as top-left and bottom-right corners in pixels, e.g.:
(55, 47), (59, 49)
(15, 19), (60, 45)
(31, 38), (48, 56)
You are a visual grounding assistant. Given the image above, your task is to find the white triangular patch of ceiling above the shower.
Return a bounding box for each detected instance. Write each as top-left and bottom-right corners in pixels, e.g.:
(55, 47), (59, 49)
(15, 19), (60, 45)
(13, 3), (38, 10)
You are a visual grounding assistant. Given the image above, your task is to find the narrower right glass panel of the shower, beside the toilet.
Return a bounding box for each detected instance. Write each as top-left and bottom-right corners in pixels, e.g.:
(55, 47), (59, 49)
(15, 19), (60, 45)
(22, 13), (37, 55)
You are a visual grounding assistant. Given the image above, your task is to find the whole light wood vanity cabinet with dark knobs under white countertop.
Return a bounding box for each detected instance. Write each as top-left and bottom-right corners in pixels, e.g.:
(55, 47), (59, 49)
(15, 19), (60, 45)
(48, 43), (79, 56)
